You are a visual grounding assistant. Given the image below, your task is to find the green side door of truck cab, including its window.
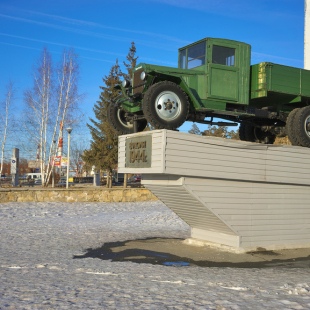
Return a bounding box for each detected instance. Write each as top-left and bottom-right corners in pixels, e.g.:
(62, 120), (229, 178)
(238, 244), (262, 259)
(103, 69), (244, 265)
(208, 42), (240, 102)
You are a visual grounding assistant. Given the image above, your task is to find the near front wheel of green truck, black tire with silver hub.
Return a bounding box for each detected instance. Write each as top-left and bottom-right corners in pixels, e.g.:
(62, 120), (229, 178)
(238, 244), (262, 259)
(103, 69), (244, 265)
(142, 81), (189, 130)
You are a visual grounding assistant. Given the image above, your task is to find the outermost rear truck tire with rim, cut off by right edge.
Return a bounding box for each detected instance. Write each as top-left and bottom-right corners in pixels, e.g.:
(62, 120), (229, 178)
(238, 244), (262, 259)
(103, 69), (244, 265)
(294, 106), (310, 147)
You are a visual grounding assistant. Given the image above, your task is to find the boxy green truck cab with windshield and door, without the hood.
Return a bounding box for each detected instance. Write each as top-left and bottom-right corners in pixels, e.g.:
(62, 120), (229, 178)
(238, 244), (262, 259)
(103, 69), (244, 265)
(178, 38), (251, 106)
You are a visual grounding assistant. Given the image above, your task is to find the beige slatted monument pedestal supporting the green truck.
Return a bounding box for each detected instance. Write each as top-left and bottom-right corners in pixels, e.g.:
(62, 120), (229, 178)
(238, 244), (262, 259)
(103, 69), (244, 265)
(119, 130), (310, 252)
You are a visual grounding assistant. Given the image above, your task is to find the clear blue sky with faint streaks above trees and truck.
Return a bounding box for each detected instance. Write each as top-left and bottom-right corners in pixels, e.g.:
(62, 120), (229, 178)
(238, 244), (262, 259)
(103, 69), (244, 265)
(0, 0), (304, 160)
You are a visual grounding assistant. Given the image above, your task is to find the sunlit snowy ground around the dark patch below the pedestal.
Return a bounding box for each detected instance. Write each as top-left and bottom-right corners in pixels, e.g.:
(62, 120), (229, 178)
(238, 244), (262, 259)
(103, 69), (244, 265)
(0, 201), (310, 310)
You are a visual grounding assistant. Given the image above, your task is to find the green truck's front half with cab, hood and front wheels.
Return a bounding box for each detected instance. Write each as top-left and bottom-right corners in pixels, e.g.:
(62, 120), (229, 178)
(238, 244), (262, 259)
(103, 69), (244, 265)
(108, 38), (251, 133)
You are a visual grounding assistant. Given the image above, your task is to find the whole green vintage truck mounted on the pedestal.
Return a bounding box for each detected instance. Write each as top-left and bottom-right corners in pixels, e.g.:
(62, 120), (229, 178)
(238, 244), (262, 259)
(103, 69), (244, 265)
(108, 38), (310, 147)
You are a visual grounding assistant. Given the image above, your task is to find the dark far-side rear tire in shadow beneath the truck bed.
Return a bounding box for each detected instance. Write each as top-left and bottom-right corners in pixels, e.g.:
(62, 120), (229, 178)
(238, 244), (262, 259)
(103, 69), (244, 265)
(239, 123), (276, 144)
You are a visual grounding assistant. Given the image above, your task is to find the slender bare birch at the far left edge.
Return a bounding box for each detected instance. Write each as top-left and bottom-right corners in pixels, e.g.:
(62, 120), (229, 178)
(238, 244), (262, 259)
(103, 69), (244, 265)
(0, 82), (14, 175)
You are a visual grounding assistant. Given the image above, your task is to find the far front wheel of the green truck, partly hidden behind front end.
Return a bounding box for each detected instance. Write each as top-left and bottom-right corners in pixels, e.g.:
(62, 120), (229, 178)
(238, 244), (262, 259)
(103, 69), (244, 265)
(108, 104), (147, 135)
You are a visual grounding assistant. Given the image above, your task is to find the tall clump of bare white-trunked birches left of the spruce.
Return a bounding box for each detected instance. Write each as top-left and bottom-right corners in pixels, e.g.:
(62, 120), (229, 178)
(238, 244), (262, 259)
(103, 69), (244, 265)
(25, 49), (80, 185)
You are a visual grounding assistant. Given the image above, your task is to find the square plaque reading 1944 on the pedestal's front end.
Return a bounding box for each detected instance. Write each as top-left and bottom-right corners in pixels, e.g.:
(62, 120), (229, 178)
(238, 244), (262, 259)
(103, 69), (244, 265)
(126, 135), (152, 168)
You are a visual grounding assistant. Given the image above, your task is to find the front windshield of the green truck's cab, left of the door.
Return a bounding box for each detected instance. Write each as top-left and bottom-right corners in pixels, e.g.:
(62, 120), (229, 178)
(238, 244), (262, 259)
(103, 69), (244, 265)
(179, 42), (206, 69)
